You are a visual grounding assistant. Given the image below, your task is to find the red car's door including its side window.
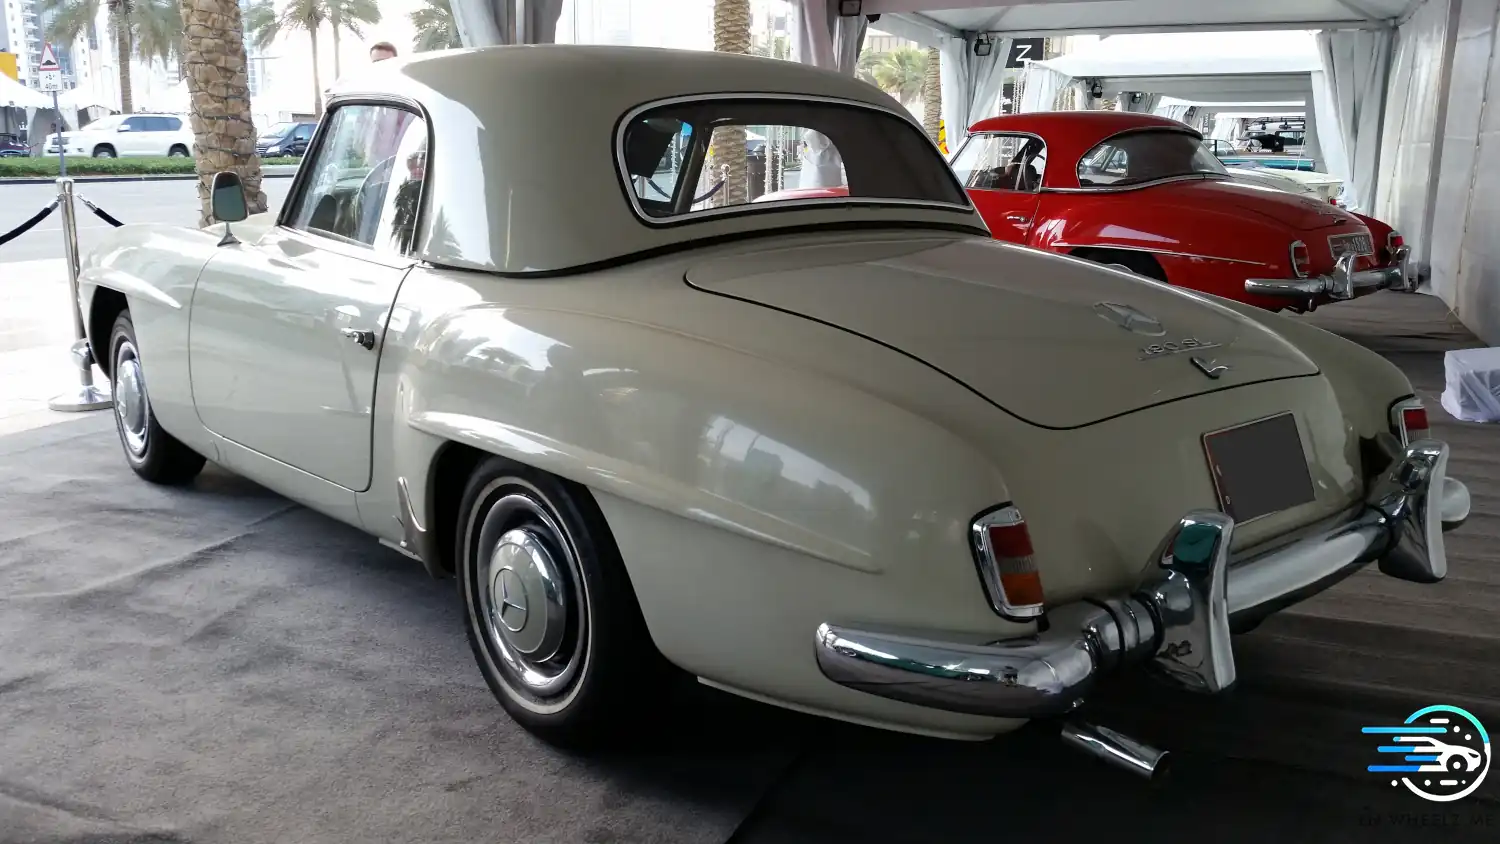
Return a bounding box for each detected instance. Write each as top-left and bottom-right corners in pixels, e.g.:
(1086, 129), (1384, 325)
(953, 132), (1047, 244)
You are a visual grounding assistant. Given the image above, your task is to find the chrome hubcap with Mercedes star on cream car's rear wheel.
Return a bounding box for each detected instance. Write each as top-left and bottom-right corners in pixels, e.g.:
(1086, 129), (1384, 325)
(476, 493), (588, 699)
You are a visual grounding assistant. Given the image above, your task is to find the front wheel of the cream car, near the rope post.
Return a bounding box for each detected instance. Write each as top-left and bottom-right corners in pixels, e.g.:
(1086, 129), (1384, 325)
(110, 310), (204, 486)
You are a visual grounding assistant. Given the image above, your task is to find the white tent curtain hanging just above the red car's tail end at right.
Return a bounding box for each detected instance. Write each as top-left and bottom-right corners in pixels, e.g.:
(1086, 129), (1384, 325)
(1313, 30), (1392, 210)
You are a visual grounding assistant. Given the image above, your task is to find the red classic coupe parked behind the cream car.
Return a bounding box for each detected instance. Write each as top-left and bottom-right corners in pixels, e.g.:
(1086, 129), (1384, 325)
(758, 111), (1415, 312)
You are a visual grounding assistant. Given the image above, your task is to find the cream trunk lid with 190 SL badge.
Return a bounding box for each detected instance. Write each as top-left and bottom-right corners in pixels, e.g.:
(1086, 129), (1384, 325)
(687, 235), (1319, 429)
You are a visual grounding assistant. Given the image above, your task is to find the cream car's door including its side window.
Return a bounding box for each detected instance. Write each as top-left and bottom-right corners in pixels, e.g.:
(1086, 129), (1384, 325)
(189, 102), (428, 492)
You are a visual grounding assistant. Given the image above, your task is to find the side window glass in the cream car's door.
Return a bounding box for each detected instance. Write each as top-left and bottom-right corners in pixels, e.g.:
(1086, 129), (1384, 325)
(288, 103), (428, 252)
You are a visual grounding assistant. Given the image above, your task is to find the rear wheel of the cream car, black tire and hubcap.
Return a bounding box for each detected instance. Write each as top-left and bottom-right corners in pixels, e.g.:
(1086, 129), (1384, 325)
(455, 457), (671, 750)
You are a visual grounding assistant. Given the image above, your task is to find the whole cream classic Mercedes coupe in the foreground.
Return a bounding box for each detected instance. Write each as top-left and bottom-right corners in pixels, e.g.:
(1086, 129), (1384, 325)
(80, 46), (1469, 772)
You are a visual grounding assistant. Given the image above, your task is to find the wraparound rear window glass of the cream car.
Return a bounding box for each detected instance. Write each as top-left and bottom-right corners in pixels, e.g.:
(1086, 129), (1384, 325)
(618, 97), (971, 222)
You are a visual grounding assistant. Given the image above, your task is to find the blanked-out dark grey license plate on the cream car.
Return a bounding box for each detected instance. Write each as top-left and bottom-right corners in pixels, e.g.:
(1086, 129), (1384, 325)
(1203, 414), (1314, 522)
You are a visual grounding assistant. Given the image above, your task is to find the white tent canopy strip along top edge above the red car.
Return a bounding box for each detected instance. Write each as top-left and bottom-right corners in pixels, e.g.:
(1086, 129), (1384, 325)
(861, 0), (1422, 36)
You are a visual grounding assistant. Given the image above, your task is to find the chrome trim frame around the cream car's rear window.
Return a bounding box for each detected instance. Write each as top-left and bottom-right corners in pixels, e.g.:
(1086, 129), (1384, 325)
(614, 91), (978, 228)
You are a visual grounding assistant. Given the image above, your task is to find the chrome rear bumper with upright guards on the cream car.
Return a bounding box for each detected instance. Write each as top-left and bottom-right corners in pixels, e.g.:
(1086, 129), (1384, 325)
(816, 439), (1470, 718)
